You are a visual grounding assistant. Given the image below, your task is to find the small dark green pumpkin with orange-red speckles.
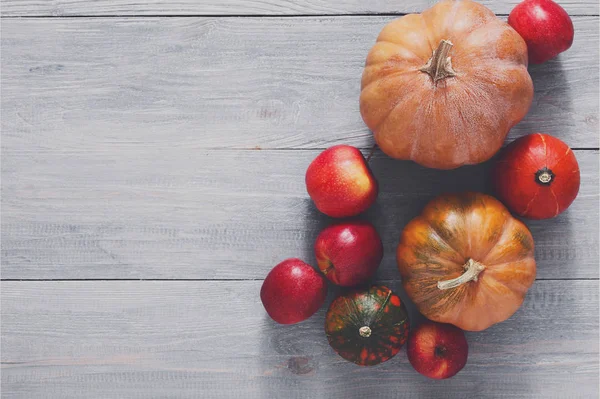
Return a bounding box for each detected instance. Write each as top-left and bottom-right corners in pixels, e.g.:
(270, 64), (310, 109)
(325, 285), (409, 366)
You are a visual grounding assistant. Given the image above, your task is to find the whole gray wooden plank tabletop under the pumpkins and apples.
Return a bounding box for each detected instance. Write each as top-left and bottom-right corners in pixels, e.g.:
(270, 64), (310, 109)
(1, 0), (600, 399)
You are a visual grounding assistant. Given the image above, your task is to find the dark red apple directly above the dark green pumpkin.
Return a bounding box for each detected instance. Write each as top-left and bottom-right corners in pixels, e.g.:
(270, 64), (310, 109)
(315, 221), (383, 287)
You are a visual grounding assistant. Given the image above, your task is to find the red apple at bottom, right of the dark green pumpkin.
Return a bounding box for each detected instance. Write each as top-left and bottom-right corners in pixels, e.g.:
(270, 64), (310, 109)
(406, 322), (469, 380)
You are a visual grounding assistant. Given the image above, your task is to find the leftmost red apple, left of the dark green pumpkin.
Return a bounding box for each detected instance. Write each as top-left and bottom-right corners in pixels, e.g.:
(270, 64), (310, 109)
(260, 258), (327, 324)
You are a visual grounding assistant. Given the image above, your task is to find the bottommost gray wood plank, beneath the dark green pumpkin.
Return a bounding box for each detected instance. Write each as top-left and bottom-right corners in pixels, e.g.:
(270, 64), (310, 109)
(1, 281), (599, 399)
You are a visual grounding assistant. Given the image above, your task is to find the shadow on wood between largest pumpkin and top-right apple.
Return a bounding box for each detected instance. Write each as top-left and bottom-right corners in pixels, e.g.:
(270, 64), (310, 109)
(508, 55), (577, 142)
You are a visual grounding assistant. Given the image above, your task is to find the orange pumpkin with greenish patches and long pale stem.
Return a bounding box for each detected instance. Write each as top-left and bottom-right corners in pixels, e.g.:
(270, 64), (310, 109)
(397, 193), (535, 331)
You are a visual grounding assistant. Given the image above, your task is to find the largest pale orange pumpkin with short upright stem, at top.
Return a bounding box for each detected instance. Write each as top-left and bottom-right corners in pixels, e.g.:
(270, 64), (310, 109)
(360, 0), (533, 169)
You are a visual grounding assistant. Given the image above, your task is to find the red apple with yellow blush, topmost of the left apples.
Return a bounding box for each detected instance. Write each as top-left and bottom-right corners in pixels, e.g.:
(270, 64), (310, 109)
(306, 145), (379, 218)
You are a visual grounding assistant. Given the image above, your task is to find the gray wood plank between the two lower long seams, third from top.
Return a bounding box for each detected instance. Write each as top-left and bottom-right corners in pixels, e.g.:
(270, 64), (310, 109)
(2, 148), (599, 279)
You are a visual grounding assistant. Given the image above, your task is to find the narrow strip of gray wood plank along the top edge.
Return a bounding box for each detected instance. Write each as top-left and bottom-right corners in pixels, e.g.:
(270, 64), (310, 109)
(2, 0), (598, 16)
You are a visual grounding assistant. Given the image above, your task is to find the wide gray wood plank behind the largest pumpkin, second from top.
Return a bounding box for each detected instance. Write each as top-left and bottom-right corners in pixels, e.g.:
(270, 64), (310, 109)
(1, 16), (600, 155)
